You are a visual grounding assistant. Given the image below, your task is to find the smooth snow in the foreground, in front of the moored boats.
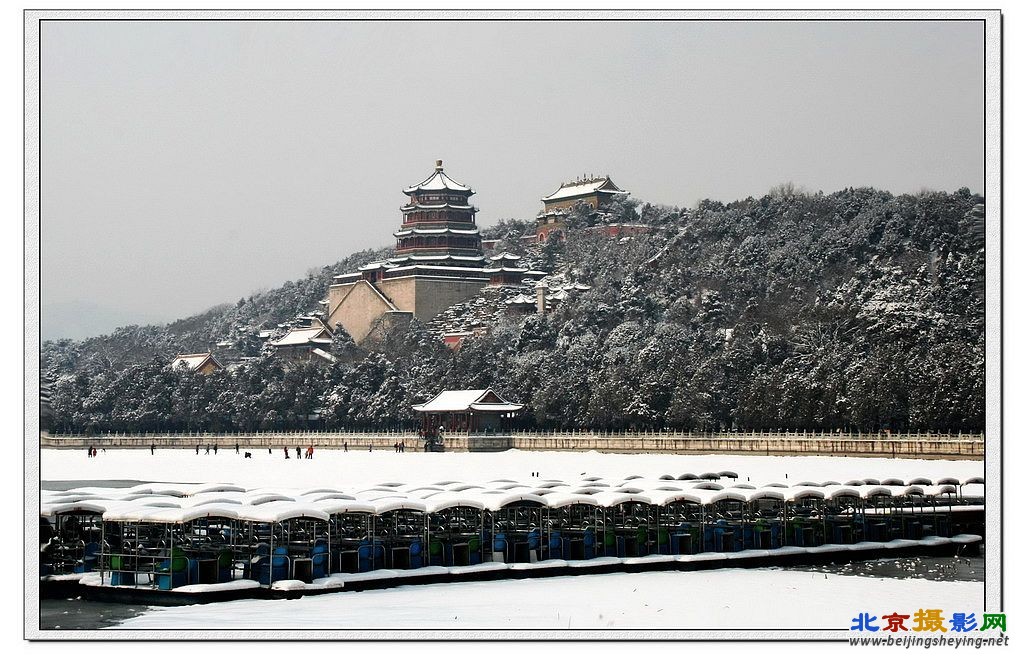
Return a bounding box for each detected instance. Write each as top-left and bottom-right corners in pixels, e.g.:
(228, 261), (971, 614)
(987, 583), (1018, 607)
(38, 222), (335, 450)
(112, 569), (983, 632)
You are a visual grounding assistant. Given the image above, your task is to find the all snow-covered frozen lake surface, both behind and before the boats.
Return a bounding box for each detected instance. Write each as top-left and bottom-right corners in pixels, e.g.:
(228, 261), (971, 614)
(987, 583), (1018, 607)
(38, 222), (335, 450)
(40, 446), (983, 636)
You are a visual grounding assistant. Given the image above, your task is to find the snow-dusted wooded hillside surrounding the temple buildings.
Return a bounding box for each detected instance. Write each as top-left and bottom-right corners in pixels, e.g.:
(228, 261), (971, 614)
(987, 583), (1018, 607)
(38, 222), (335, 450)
(42, 187), (985, 431)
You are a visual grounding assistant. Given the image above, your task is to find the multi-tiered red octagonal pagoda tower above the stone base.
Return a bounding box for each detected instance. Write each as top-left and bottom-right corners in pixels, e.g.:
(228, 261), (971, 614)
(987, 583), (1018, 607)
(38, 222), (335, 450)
(389, 161), (484, 268)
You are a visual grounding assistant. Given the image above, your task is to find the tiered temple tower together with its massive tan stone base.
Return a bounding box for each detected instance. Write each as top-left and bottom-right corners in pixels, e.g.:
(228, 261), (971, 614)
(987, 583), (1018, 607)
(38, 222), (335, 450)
(325, 161), (501, 343)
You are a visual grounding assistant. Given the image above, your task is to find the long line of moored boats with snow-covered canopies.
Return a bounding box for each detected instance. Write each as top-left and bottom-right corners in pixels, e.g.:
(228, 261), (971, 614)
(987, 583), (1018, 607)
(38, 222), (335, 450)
(40, 470), (984, 598)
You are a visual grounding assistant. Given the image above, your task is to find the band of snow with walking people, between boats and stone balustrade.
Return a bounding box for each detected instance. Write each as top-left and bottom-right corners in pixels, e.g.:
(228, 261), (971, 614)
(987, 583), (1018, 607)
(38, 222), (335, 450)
(40, 446), (984, 488)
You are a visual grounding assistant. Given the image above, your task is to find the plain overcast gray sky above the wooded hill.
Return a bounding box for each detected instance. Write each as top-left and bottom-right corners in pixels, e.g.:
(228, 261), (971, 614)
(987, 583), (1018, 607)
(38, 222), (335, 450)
(41, 21), (984, 339)
